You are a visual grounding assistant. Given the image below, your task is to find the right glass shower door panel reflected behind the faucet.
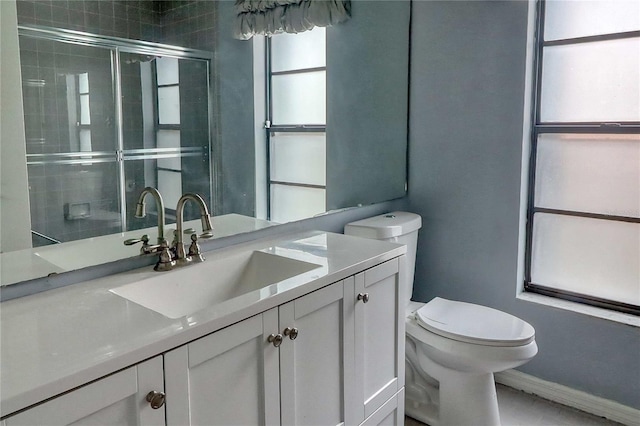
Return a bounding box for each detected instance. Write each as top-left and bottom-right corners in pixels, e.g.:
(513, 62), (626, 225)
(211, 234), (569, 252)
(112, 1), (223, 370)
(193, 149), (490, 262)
(120, 52), (211, 233)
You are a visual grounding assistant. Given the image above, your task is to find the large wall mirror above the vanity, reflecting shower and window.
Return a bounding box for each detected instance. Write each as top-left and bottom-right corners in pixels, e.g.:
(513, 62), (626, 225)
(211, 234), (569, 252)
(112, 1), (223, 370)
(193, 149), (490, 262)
(2, 0), (409, 284)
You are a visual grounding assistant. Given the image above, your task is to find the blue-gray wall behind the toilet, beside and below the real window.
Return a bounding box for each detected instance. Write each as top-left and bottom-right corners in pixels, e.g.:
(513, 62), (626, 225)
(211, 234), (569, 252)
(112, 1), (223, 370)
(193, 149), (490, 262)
(409, 1), (640, 408)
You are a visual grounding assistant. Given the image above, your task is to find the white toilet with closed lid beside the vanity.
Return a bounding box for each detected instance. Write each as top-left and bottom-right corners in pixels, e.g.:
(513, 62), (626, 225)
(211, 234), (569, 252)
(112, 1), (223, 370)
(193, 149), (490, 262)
(344, 212), (538, 426)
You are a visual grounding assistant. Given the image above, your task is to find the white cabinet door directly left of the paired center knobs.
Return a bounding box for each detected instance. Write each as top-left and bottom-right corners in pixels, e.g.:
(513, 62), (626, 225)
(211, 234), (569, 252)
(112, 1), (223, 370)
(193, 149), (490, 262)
(165, 308), (280, 425)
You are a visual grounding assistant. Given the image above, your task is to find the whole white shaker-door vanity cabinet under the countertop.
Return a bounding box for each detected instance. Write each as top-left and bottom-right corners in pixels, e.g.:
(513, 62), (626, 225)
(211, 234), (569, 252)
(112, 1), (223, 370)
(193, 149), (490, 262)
(0, 245), (404, 426)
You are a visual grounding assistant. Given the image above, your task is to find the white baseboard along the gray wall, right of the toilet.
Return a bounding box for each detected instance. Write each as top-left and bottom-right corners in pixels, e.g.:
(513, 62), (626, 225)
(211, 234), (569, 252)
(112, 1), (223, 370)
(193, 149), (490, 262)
(495, 370), (640, 426)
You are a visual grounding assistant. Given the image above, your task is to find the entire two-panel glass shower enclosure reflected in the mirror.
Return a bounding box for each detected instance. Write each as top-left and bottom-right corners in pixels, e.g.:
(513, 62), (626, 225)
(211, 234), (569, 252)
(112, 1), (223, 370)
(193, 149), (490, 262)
(19, 26), (213, 246)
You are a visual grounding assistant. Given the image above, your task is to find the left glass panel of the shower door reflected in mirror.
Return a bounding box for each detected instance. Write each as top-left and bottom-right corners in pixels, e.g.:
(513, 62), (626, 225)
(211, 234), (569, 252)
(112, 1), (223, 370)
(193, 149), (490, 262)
(20, 35), (122, 247)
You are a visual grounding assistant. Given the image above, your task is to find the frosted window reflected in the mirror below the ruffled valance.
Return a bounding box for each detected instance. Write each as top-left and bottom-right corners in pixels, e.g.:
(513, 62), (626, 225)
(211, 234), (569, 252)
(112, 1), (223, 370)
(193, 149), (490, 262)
(266, 28), (326, 223)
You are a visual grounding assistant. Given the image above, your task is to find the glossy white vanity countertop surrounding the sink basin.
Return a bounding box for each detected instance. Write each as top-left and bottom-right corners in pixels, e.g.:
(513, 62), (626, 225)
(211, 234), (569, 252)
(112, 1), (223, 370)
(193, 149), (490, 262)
(0, 232), (406, 417)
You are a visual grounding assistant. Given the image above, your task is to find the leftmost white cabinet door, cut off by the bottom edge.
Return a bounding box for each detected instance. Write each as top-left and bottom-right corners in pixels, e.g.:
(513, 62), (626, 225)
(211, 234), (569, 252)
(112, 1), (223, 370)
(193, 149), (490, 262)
(5, 356), (165, 426)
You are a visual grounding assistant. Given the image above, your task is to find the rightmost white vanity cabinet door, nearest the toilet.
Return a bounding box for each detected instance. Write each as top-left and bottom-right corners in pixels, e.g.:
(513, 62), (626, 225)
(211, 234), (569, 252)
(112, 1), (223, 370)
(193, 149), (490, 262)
(355, 256), (404, 422)
